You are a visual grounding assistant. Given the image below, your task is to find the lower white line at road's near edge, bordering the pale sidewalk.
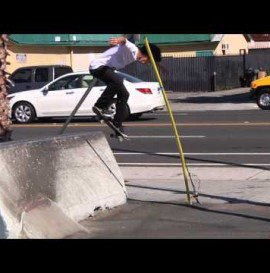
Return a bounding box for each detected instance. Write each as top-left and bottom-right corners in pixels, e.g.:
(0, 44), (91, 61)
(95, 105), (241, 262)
(118, 163), (270, 167)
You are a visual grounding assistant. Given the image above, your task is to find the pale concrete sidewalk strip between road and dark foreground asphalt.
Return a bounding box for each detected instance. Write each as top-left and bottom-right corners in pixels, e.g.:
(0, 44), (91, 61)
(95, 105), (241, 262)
(121, 167), (270, 204)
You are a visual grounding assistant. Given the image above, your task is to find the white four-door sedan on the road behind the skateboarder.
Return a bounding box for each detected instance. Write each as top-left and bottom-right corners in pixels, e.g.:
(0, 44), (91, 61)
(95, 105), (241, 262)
(8, 71), (165, 123)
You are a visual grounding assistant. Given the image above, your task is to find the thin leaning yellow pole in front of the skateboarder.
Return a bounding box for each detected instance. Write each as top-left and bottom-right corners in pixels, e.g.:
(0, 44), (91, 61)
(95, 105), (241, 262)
(145, 37), (192, 205)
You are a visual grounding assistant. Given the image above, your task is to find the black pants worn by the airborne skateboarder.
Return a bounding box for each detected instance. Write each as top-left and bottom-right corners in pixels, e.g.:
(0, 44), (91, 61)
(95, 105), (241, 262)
(90, 66), (129, 125)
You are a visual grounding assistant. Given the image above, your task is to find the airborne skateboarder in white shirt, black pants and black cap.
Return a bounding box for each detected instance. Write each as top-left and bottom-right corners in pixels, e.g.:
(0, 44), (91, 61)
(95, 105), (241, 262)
(89, 37), (161, 133)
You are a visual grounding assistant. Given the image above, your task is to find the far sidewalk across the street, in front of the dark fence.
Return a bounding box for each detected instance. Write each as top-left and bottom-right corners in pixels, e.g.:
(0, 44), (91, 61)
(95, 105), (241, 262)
(163, 88), (259, 111)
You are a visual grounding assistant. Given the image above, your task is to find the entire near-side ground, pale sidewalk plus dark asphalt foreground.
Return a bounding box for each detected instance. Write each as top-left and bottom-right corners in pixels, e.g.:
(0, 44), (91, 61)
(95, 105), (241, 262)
(81, 167), (270, 239)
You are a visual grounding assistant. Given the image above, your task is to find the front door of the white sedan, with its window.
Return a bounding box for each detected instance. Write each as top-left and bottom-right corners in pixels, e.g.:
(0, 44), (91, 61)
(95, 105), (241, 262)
(37, 75), (85, 117)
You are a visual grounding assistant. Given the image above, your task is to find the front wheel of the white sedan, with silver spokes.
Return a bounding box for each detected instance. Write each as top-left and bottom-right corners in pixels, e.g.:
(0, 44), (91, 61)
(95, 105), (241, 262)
(13, 102), (36, 123)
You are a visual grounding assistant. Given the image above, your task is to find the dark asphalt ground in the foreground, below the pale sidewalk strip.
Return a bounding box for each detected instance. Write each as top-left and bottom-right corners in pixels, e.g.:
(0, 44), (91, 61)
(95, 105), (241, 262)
(81, 199), (270, 239)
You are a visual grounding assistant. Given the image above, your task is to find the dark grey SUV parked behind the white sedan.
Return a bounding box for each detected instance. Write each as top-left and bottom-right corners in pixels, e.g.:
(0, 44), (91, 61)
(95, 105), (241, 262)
(9, 65), (73, 94)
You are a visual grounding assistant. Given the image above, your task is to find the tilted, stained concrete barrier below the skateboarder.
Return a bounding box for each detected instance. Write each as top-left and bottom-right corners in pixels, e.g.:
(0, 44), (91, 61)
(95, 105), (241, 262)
(0, 132), (127, 238)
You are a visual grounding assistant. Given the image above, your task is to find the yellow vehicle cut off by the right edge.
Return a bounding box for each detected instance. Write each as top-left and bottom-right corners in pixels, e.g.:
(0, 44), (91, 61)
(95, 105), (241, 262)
(250, 76), (270, 110)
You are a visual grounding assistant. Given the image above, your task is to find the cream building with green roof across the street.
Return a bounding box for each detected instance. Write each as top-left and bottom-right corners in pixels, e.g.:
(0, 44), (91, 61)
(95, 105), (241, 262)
(8, 34), (248, 73)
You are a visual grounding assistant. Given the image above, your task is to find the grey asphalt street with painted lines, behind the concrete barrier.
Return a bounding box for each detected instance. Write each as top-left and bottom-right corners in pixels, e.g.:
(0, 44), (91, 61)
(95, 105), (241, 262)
(8, 109), (270, 169)
